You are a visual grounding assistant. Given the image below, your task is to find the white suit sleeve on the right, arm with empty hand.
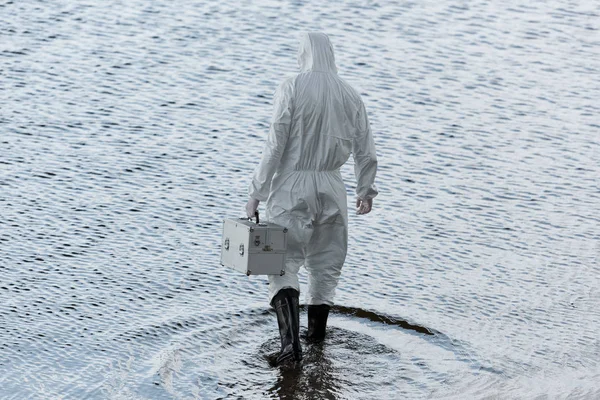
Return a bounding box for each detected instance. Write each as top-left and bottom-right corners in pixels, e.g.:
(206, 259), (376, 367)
(352, 101), (379, 200)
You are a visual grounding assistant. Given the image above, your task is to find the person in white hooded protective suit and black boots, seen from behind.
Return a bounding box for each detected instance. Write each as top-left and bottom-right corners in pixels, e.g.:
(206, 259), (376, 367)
(246, 33), (377, 363)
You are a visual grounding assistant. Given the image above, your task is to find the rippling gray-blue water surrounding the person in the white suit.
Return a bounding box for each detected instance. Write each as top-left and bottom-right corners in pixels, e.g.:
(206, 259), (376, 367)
(0, 0), (600, 399)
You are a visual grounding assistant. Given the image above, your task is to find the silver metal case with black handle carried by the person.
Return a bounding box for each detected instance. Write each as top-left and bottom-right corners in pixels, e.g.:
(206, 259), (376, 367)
(221, 213), (287, 275)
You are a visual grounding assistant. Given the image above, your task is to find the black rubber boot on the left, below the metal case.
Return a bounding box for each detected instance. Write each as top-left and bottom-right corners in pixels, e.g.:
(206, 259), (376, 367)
(271, 288), (302, 365)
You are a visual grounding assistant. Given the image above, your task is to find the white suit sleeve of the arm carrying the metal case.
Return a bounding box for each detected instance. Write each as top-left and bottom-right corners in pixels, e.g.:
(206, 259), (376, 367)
(248, 80), (293, 201)
